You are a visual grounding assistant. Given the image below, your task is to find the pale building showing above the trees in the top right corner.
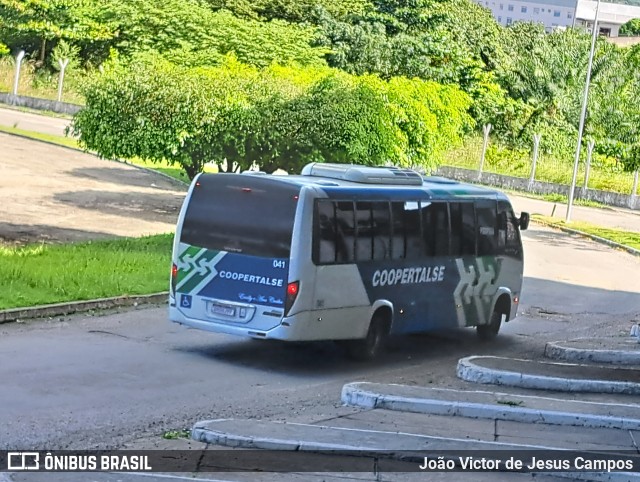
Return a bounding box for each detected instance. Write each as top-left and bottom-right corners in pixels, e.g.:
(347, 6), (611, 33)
(476, 0), (640, 37)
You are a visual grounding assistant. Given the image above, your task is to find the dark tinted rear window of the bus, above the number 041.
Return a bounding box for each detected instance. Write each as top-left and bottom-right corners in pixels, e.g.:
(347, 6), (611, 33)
(180, 174), (300, 258)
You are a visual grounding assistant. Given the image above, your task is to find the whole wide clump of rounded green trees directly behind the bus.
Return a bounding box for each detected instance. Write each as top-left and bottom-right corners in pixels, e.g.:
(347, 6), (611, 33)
(72, 56), (471, 178)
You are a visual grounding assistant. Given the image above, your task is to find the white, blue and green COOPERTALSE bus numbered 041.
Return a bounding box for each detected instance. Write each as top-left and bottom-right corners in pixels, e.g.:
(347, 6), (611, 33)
(170, 163), (529, 359)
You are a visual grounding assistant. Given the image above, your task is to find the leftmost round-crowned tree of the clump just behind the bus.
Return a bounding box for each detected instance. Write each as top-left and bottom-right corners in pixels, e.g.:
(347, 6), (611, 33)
(71, 55), (218, 178)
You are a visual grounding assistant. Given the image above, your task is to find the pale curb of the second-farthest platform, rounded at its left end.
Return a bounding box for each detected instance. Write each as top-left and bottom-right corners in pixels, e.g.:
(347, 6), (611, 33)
(456, 356), (640, 395)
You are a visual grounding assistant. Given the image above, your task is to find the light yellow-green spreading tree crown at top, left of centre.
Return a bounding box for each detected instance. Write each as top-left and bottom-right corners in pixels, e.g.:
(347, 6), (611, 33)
(92, 0), (326, 66)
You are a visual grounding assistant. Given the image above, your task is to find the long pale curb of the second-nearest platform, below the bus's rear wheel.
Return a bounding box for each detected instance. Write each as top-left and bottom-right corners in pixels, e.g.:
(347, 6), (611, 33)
(342, 383), (640, 430)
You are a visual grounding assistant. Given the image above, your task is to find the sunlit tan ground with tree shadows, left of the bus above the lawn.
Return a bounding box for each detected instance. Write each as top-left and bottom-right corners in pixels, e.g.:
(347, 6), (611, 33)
(0, 134), (187, 245)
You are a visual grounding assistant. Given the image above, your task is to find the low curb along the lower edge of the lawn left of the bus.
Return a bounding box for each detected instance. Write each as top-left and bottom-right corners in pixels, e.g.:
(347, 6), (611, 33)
(0, 291), (169, 324)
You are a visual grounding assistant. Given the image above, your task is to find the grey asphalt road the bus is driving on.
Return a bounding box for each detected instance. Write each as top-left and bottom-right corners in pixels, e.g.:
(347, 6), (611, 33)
(0, 227), (640, 449)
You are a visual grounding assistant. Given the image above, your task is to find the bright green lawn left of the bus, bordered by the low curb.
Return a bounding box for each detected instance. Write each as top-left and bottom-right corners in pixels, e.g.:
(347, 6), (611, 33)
(0, 234), (173, 309)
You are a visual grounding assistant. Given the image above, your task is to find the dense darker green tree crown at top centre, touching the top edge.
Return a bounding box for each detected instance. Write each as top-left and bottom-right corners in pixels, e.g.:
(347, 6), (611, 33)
(318, 0), (504, 96)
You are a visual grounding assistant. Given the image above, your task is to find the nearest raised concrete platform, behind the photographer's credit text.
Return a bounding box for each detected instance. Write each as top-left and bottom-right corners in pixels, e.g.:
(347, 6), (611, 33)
(192, 416), (640, 482)
